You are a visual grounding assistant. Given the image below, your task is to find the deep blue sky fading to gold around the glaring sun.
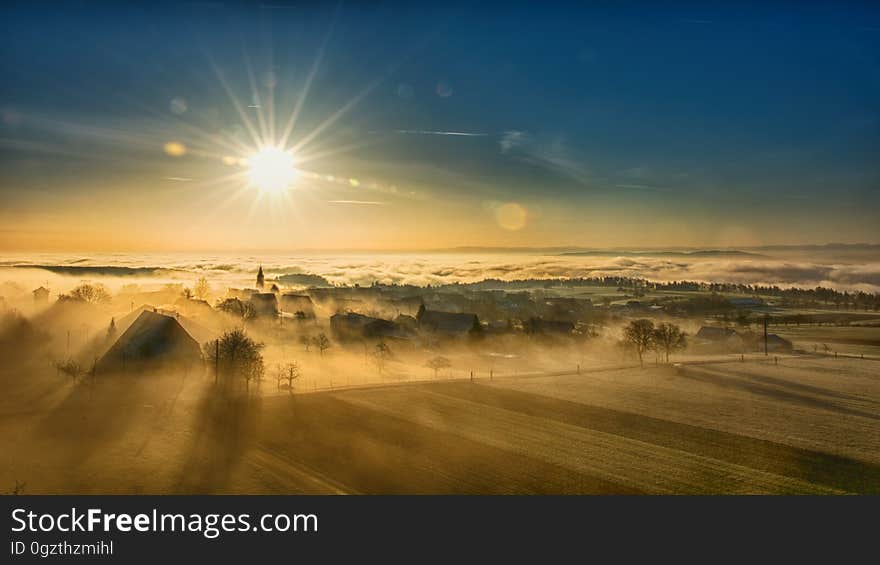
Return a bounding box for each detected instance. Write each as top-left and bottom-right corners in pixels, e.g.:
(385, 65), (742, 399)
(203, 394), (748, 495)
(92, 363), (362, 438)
(0, 2), (880, 247)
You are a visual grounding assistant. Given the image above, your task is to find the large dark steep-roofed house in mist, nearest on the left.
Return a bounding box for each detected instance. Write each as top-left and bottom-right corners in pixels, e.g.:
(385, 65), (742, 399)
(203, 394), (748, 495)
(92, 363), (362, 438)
(95, 310), (202, 373)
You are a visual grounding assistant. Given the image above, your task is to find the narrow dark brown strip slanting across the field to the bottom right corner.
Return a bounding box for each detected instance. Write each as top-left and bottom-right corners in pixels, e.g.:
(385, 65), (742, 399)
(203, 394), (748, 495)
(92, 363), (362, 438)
(424, 383), (880, 494)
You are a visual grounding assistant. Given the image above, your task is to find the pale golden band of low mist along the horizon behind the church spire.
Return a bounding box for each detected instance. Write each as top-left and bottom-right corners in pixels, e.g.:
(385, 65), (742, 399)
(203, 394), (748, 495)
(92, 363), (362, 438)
(0, 246), (880, 295)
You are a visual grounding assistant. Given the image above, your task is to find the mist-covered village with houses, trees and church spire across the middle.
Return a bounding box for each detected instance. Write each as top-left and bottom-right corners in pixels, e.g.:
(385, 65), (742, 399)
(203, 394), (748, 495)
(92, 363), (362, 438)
(3, 267), (876, 390)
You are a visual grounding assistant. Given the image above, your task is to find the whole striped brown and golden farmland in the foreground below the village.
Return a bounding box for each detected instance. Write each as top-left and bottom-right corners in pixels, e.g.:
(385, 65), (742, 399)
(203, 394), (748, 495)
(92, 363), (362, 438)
(0, 355), (880, 493)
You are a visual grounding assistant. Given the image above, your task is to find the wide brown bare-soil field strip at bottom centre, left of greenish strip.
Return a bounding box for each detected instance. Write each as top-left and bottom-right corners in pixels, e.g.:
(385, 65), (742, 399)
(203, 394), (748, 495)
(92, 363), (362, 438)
(248, 393), (640, 494)
